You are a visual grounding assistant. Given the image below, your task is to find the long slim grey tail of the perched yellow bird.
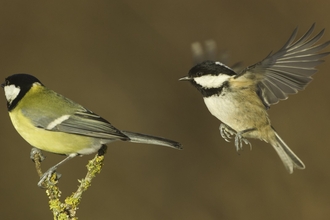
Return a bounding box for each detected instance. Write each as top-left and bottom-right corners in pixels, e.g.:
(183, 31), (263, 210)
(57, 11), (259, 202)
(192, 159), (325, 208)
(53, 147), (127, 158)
(121, 131), (182, 149)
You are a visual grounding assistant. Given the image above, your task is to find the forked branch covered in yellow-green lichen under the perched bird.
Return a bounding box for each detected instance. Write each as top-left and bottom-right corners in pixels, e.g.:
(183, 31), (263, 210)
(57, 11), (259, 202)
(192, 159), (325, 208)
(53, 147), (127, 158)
(34, 145), (106, 220)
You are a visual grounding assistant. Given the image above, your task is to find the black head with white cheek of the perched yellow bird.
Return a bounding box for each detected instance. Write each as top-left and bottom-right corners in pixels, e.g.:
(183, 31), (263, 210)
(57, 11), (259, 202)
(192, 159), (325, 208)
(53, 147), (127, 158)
(1, 73), (42, 111)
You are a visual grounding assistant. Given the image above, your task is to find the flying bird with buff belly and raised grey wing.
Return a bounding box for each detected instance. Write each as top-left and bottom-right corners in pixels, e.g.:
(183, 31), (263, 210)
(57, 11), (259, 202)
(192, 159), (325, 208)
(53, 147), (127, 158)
(179, 23), (330, 174)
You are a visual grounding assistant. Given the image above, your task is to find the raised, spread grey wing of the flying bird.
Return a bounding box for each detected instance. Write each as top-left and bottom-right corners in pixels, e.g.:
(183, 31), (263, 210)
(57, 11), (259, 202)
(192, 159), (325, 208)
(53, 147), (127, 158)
(237, 24), (330, 107)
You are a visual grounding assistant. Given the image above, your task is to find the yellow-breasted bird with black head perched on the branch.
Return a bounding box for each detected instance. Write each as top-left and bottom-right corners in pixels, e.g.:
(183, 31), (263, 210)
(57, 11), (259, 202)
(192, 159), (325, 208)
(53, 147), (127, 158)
(1, 73), (182, 187)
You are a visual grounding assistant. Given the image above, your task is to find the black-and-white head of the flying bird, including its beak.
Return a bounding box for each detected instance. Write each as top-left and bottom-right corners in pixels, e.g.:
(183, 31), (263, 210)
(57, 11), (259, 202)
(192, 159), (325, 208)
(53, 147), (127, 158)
(179, 60), (236, 97)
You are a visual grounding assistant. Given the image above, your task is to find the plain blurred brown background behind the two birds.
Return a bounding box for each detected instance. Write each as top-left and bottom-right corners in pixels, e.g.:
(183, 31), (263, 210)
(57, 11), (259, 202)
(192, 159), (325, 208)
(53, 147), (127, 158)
(0, 0), (330, 220)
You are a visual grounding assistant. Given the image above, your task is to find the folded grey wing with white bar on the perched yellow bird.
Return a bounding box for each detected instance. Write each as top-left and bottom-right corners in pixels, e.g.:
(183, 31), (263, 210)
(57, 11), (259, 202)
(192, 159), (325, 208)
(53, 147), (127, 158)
(45, 109), (129, 140)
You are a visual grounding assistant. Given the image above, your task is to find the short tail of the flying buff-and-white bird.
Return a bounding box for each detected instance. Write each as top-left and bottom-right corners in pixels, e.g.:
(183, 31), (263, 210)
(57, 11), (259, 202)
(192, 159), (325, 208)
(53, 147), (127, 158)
(272, 130), (305, 174)
